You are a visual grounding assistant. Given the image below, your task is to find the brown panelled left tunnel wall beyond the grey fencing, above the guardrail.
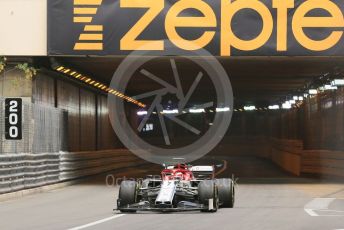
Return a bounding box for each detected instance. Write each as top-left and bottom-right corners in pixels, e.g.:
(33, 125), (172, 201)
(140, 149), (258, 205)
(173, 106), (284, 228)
(32, 73), (122, 151)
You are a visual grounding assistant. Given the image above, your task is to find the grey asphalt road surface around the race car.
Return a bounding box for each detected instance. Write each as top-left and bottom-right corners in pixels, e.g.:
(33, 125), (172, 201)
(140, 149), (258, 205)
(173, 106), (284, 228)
(0, 157), (344, 230)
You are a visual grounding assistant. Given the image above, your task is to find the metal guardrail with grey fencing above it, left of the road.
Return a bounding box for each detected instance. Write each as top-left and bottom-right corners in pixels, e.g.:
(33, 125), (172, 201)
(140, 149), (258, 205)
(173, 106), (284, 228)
(0, 97), (143, 194)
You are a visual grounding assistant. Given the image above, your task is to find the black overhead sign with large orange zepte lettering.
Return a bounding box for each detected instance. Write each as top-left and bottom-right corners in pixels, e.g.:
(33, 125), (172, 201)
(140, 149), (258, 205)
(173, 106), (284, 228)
(48, 0), (344, 56)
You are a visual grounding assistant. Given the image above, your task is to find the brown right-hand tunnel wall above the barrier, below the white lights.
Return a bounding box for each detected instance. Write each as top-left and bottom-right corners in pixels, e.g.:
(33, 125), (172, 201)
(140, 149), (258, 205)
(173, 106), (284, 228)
(228, 88), (344, 151)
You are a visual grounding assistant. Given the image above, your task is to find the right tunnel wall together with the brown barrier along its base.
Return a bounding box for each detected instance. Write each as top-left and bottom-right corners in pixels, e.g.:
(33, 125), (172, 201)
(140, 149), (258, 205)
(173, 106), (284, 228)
(226, 88), (344, 177)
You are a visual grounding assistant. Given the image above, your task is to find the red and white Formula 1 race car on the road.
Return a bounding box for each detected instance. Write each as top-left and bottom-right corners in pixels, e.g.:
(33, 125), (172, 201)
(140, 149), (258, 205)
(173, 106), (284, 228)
(117, 164), (235, 212)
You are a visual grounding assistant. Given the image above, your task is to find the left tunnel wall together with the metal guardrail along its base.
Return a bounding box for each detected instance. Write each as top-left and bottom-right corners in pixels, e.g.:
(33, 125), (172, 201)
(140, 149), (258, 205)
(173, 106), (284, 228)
(0, 70), (146, 194)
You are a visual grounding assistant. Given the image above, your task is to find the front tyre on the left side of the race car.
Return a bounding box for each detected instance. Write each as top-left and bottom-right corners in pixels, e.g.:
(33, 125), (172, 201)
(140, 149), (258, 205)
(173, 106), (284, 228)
(118, 180), (138, 212)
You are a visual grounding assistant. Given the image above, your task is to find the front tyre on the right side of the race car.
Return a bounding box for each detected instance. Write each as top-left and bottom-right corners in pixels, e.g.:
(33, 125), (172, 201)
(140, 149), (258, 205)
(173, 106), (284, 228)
(198, 180), (219, 212)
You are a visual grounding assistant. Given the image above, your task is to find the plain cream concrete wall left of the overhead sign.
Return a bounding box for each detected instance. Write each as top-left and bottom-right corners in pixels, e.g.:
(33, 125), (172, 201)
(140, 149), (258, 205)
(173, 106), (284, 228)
(0, 0), (47, 56)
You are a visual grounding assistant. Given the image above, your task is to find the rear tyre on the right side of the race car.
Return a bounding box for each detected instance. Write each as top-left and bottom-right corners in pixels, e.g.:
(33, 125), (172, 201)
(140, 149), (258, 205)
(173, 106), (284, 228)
(216, 178), (235, 208)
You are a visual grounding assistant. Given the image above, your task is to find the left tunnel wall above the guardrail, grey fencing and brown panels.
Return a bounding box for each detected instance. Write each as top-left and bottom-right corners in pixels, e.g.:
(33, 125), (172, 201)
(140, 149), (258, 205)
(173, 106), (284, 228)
(0, 67), (127, 153)
